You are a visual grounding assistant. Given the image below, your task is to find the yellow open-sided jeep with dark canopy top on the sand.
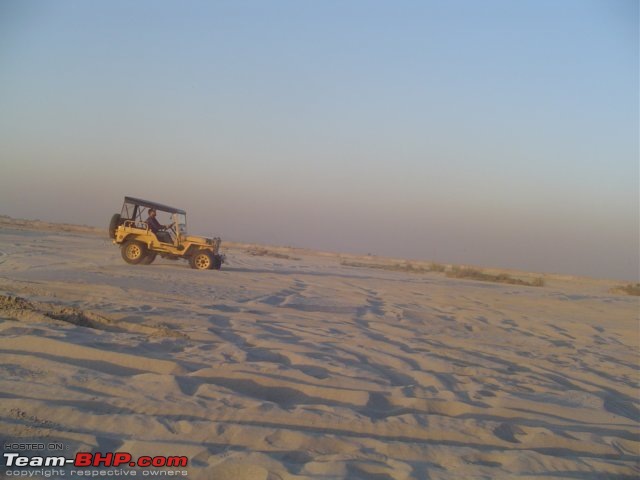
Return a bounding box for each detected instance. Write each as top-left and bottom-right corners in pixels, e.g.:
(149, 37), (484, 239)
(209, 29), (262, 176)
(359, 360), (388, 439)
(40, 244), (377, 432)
(109, 197), (224, 270)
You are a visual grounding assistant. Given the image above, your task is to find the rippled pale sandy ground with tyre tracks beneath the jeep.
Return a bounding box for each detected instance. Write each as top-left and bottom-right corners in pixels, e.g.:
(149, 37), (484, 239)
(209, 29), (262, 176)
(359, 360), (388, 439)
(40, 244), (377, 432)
(0, 221), (640, 480)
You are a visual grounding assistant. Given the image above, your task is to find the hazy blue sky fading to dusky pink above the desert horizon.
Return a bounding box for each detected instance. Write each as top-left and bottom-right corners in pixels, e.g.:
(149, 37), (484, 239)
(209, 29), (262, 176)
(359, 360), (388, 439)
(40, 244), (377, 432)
(0, 0), (640, 280)
